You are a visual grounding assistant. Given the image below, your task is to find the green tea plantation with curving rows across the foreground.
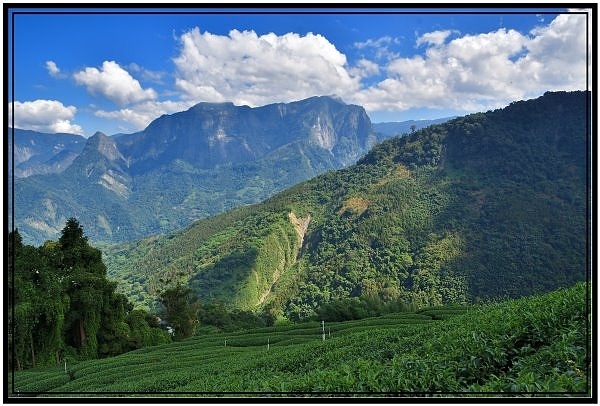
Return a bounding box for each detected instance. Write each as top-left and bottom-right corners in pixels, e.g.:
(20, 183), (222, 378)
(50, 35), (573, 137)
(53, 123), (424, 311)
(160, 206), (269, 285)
(8, 283), (592, 398)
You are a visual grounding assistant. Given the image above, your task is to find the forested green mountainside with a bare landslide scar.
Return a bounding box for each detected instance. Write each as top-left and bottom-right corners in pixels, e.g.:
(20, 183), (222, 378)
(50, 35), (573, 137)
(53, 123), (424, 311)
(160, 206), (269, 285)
(103, 92), (590, 320)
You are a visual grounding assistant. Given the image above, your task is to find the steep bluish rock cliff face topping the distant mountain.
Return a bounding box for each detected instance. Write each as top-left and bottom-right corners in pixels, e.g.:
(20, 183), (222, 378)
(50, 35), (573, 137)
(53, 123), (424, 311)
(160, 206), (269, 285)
(117, 97), (376, 173)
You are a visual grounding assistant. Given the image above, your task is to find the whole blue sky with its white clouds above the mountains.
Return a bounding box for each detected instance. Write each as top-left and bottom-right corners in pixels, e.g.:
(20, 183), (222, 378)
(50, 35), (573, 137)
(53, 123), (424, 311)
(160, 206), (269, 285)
(8, 8), (591, 136)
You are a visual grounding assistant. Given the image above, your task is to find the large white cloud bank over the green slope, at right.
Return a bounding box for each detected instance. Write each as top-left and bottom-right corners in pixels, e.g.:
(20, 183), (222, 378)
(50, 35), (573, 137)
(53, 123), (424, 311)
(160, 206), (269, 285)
(353, 14), (587, 111)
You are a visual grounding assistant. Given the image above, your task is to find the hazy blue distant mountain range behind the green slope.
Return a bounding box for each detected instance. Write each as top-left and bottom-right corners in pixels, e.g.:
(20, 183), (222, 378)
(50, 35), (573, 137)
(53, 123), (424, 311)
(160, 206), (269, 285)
(9, 96), (418, 244)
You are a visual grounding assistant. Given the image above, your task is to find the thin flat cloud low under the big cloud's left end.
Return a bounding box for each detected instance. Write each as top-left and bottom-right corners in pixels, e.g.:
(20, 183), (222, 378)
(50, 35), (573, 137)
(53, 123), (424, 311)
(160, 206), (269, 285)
(94, 101), (193, 130)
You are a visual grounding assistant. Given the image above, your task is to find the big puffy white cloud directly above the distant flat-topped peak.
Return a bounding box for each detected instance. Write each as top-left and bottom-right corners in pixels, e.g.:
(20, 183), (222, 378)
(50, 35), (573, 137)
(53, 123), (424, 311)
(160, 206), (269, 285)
(174, 28), (360, 106)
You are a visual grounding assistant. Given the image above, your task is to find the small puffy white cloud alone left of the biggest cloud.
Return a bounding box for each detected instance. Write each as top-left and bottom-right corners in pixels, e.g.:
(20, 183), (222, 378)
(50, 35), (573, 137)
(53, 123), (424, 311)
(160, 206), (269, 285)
(73, 61), (158, 106)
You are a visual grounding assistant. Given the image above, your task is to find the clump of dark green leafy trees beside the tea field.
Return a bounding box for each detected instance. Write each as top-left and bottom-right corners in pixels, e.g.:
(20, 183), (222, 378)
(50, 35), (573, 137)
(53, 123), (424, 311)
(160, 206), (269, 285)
(8, 219), (169, 369)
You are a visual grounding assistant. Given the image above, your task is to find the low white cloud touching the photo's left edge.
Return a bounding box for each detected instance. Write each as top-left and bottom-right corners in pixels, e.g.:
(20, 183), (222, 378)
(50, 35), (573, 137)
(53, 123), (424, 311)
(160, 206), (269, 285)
(8, 100), (83, 134)
